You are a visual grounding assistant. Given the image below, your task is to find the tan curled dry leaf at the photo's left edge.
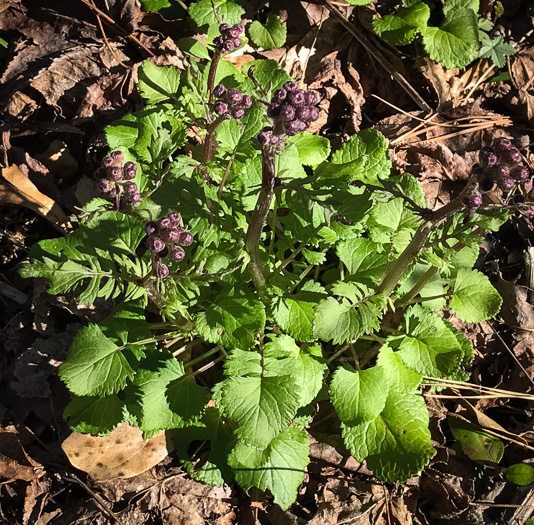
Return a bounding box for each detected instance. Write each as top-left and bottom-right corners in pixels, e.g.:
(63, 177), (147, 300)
(0, 165), (71, 228)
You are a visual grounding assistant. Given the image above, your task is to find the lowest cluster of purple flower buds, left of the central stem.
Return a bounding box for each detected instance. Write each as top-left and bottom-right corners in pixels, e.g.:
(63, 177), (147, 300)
(145, 211), (193, 278)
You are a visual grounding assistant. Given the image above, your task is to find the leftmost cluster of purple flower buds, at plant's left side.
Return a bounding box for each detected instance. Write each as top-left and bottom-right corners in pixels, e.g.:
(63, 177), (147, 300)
(95, 151), (141, 204)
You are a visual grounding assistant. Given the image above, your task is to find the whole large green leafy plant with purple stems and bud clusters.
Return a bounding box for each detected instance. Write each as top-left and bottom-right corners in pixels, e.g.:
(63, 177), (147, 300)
(21, 20), (534, 509)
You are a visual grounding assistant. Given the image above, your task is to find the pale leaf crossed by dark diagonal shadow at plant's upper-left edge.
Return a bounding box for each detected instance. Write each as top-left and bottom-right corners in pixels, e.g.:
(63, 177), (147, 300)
(137, 60), (180, 104)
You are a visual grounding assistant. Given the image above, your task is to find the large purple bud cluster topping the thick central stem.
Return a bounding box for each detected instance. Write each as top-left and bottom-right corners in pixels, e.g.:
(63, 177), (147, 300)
(258, 81), (319, 146)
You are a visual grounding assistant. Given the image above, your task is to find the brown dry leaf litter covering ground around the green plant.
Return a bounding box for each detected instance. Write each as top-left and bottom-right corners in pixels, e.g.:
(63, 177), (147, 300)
(0, 0), (534, 524)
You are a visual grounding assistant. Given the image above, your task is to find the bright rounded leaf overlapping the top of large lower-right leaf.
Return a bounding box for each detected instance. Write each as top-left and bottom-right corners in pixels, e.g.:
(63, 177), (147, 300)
(330, 365), (388, 426)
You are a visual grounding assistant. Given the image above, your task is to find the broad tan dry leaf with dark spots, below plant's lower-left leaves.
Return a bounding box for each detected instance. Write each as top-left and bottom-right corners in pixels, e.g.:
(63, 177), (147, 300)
(61, 422), (169, 483)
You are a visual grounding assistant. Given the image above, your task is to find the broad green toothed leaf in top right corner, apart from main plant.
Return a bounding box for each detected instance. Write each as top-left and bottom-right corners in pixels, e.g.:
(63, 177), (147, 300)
(422, 9), (480, 69)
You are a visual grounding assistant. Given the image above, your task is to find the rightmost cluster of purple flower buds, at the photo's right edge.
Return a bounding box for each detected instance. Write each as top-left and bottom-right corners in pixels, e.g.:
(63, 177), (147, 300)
(466, 138), (534, 216)
